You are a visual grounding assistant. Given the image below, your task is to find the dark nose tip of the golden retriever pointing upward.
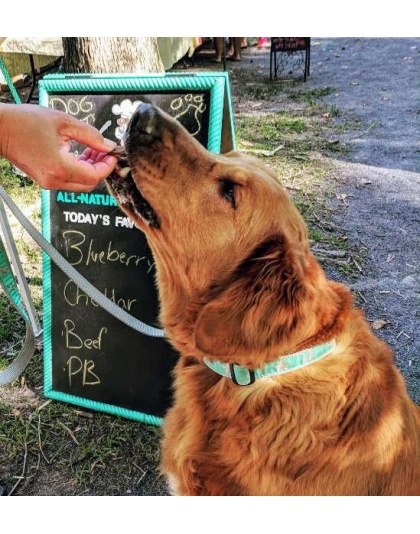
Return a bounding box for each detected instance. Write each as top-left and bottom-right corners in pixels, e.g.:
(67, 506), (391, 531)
(124, 102), (162, 152)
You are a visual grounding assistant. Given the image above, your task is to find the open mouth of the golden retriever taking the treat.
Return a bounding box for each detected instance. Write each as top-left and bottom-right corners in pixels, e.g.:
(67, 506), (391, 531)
(106, 147), (160, 229)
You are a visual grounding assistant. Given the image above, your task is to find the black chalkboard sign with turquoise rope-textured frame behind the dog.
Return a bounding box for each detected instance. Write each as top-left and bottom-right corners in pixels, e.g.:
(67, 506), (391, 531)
(39, 73), (234, 425)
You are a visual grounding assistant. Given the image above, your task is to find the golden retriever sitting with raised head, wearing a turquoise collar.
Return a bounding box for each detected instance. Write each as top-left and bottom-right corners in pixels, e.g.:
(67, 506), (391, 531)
(108, 103), (420, 495)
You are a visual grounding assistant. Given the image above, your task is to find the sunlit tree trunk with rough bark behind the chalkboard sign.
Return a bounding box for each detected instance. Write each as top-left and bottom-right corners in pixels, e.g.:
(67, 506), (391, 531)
(63, 37), (164, 74)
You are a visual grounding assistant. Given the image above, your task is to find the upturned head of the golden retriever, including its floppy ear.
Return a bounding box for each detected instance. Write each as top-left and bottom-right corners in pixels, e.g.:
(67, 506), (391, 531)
(108, 104), (344, 363)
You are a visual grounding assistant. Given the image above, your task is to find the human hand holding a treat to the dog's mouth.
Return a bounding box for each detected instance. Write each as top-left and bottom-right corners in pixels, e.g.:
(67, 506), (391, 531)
(0, 104), (117, 192)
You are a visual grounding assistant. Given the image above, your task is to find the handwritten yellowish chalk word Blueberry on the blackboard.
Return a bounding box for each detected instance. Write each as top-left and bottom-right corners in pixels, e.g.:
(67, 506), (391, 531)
(63, 230), (147, 267)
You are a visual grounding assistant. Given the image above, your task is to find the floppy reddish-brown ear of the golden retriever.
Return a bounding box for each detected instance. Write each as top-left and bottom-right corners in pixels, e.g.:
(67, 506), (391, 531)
(195, 236), (306, 363)
